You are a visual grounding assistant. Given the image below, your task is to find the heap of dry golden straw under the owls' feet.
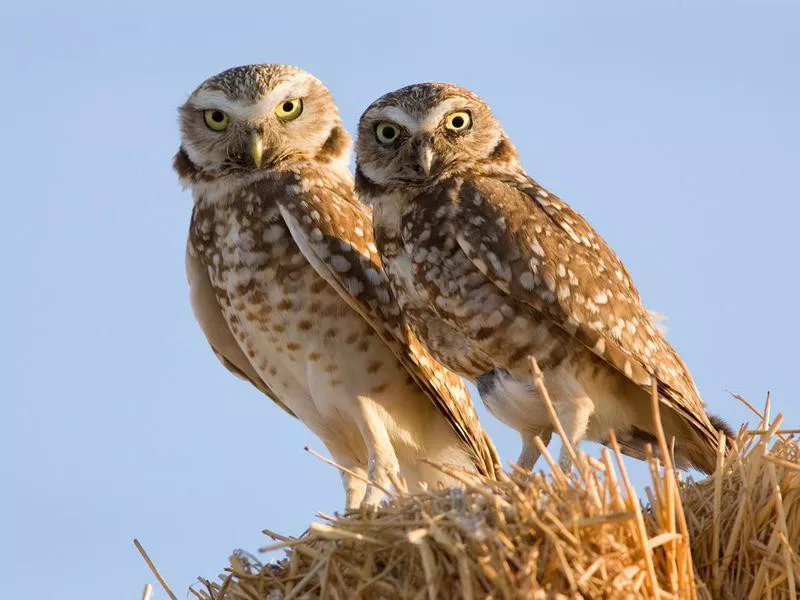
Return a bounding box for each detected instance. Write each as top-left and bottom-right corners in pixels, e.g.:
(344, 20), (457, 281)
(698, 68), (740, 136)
(147, 369), (800, 600)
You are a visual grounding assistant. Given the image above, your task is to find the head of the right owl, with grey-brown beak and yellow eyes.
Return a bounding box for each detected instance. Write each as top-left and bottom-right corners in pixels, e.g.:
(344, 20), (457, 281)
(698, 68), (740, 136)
(356, 83), (517, 187)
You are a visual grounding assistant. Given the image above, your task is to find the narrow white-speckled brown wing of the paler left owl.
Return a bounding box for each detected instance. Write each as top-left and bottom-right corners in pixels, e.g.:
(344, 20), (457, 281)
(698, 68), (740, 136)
(276, 173), (499, 476)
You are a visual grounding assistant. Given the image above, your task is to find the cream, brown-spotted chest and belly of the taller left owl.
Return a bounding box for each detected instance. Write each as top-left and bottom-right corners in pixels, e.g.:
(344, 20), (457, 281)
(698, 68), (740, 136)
(204, 204), (454, 469)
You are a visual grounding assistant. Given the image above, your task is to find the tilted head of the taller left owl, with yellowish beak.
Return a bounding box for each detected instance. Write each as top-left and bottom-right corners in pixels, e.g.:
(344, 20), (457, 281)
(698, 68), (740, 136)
(174, 64), (351, 183)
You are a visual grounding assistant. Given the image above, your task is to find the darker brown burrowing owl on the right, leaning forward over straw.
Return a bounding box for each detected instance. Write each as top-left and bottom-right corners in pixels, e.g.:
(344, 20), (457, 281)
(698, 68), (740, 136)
(356, 83), (730, 472)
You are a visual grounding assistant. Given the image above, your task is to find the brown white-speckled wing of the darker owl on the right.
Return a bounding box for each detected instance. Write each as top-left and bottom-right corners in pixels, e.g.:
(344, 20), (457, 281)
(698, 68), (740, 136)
(452, 173), (716, 450)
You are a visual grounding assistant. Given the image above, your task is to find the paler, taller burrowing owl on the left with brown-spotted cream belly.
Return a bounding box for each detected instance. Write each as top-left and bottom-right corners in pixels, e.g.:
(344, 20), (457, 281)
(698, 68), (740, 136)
(174, 65), (496, 508)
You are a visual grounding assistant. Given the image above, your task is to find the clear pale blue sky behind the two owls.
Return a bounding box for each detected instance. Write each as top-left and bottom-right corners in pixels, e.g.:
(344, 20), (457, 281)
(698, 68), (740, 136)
(0, 0), (800, 600)
